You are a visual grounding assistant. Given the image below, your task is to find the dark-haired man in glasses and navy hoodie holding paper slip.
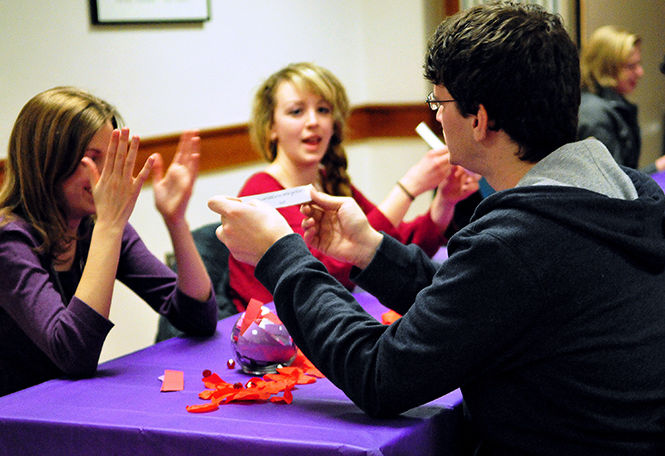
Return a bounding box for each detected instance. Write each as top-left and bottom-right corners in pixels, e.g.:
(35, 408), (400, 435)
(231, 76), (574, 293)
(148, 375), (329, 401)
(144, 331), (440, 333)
(208, 2), (665, 456)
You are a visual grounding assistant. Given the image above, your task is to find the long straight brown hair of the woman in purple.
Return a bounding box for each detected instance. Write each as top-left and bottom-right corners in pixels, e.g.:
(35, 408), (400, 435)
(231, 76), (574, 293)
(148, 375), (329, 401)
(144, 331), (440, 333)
(0, 87), (121, 257)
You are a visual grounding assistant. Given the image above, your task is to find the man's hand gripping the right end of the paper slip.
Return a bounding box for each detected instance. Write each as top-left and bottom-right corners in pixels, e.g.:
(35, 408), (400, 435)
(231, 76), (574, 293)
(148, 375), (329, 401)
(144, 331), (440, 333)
(301, 189), (383, 269)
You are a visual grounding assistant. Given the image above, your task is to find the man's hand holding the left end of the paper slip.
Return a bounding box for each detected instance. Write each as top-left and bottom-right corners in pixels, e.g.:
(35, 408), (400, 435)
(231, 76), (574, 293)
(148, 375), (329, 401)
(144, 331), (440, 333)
(208, 195), (293, 266)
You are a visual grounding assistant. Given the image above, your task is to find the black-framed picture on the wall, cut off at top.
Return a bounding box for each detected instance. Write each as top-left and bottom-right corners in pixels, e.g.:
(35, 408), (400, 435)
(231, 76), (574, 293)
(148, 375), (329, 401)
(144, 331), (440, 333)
(90, 0), (210, 24)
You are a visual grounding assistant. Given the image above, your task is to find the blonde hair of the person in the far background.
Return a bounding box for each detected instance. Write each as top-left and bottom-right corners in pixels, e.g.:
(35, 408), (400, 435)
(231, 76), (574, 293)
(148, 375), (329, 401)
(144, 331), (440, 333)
(580, 25), (642, 93)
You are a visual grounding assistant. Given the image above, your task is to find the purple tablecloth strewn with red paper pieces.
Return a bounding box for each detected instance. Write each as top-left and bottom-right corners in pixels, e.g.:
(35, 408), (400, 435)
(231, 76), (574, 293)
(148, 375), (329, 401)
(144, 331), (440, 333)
(0, 293), (462, 456)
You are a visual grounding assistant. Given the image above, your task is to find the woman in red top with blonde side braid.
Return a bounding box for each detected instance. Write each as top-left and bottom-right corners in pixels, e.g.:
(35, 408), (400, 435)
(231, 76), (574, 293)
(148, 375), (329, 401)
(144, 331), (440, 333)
(229, 63), (478, 311)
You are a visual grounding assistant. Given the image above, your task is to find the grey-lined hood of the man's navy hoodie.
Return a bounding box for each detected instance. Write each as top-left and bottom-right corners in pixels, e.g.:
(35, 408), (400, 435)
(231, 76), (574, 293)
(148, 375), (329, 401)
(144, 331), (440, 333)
(474, 140), (665, 270)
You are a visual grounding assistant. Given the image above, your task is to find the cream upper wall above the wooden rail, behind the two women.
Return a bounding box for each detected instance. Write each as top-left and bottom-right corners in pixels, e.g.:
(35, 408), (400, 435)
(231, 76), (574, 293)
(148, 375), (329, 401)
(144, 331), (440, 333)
(0, 0), (426, 157)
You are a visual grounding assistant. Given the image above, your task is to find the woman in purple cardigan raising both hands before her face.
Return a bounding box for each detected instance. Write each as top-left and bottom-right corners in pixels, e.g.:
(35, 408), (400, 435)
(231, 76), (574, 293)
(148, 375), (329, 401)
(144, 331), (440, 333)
(0, 87), (217, 395)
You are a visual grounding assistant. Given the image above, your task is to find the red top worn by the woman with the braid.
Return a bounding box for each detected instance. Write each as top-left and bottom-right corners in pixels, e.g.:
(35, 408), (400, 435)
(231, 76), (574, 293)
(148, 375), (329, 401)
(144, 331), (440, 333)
(229, 172), (447, 312)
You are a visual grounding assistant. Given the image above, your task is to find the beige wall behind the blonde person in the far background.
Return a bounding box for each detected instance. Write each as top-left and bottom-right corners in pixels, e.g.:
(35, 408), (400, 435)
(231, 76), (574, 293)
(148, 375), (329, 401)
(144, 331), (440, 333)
(580, 0), (665, 166)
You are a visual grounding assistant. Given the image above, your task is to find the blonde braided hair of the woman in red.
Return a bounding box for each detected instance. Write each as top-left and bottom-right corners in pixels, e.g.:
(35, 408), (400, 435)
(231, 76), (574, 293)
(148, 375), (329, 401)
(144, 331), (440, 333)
(249, 62), (351, 196)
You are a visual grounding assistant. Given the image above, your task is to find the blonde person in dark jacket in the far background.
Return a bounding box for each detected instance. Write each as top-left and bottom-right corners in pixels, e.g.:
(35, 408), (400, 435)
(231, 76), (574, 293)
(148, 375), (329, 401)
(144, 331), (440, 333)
(578, 25), (665, 174)
